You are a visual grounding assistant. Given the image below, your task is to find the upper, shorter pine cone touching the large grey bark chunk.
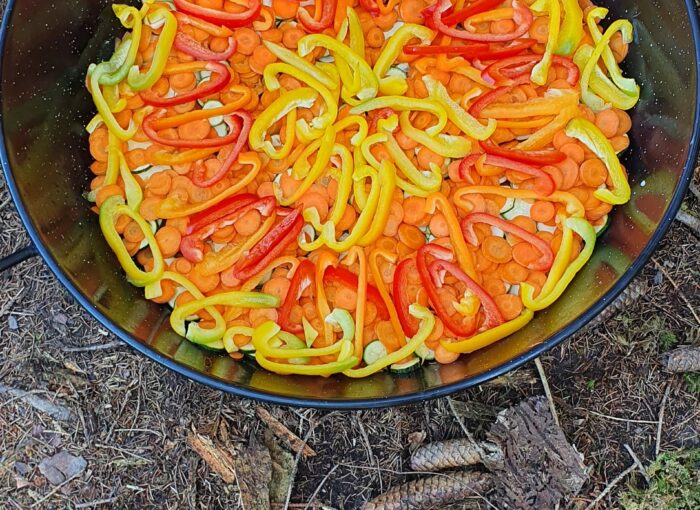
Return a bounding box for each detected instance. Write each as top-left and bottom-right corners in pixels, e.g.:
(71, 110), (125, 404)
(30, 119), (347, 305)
(411, 439), (503, 471)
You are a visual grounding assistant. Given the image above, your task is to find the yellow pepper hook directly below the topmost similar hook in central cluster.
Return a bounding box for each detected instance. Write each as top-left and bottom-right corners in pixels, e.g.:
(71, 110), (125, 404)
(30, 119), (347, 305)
(263, 62), (338, 143)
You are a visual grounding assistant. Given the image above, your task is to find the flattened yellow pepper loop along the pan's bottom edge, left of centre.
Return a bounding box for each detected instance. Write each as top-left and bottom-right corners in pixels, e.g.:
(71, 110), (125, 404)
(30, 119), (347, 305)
(252, 321), (358, 376)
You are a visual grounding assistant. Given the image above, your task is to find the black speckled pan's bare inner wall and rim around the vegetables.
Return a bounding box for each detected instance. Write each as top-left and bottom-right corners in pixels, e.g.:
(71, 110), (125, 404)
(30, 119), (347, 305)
(1, 0), (698, 407)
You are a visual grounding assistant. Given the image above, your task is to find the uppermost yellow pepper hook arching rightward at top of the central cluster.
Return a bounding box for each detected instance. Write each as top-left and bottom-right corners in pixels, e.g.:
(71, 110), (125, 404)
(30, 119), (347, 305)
(297, 34), (379, 104)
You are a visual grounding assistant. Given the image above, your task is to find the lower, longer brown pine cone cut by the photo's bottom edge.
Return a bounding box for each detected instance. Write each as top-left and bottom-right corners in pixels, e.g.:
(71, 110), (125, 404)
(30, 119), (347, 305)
(362, 471), (494, 510)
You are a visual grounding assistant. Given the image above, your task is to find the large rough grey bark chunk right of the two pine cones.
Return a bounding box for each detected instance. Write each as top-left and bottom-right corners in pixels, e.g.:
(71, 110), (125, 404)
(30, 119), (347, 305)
(485, 397), (587, 510)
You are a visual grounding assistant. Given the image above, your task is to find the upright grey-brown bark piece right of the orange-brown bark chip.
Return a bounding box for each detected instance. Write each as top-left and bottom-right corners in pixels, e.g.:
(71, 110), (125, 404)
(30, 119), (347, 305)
(233, 438), (272, 510)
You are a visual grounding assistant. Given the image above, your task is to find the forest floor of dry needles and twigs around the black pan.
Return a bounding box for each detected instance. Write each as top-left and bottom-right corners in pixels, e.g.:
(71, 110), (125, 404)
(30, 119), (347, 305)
(0, 3), (700, 509)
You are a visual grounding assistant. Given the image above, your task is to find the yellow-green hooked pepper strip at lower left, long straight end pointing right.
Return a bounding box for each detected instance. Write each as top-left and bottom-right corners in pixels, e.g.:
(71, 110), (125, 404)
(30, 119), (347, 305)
(170, 291), (280, 344)
